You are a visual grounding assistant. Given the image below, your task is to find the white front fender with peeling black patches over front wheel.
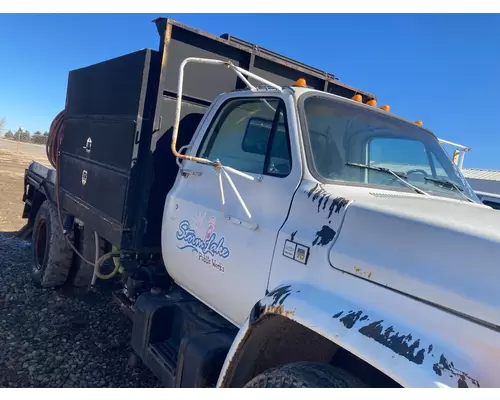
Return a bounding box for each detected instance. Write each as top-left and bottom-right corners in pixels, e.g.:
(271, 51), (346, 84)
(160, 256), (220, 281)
(217, 282), (486, 387)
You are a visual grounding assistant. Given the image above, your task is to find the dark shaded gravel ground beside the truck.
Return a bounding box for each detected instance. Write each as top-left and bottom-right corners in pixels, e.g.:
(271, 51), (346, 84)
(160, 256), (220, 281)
(0, 232), (159, 387)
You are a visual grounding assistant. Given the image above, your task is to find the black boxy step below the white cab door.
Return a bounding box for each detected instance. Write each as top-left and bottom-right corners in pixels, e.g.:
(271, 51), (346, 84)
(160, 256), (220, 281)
(131, 291), (238, 388)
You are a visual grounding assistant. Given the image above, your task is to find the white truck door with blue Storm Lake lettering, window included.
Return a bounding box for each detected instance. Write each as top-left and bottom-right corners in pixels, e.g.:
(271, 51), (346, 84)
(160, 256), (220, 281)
(162, 93), (301, 325)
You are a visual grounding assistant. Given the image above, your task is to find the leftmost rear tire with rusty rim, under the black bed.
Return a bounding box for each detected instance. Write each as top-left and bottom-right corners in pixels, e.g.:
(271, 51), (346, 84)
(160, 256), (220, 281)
(31, 200), (73, 288)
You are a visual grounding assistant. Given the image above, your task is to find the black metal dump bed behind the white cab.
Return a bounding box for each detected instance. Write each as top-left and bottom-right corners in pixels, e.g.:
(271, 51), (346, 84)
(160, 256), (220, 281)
(59, 18), (373, 254)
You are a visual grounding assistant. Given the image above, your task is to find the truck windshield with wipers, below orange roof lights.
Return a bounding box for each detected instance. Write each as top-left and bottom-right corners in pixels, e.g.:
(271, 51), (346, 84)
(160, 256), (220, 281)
(301, 94), (480, 203)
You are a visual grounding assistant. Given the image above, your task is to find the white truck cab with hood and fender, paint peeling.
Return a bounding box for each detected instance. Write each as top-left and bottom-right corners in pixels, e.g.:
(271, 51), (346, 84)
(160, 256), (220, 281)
(162, 57), (500, 387)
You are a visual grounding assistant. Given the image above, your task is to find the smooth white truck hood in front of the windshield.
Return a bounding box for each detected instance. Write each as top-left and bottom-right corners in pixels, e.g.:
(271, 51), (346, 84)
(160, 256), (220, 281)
(329, 192), (500, 326)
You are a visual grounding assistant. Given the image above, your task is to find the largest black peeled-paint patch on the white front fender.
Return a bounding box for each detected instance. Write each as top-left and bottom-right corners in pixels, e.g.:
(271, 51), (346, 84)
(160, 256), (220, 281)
(359, 320), (425, 364)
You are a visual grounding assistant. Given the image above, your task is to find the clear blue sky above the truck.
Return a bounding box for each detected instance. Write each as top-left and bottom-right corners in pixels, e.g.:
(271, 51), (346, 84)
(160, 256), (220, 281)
(0, 13), (500, 169)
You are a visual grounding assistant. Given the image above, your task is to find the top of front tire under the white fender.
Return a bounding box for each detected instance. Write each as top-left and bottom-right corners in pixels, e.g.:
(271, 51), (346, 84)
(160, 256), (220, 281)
(245, 362), (367, 388)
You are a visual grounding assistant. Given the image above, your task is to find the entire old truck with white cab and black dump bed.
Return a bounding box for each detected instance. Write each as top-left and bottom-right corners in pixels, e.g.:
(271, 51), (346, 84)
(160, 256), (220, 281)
(22, 23), (500, 388)
